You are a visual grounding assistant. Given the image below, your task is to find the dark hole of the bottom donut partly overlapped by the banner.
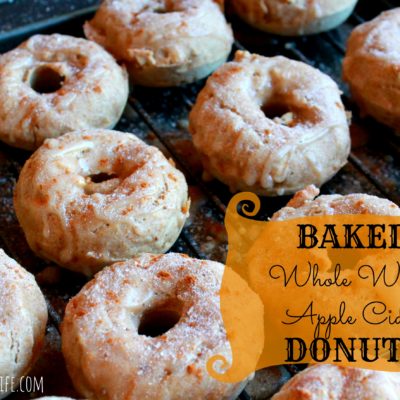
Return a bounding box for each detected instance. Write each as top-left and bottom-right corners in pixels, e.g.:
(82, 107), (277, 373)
(138, 300), (183, 337)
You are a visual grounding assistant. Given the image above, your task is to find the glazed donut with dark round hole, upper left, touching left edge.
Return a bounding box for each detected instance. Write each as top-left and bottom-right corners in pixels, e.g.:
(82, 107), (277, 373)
(0, 34), (128, 150)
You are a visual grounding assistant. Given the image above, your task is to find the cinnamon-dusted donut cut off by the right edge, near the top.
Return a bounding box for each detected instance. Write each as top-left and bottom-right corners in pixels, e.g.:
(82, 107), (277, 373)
(343, 8), (400, 130)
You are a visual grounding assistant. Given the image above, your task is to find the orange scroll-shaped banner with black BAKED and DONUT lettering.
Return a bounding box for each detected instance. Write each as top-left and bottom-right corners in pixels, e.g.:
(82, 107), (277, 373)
(207, 193), (400, 382)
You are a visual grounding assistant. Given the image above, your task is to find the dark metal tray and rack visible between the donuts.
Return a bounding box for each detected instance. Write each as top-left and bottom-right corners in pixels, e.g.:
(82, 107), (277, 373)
(0, 0), (400, 400)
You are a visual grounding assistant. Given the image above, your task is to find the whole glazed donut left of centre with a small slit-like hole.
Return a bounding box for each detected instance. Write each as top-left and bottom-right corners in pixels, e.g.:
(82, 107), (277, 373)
(14, 130), (189, 275)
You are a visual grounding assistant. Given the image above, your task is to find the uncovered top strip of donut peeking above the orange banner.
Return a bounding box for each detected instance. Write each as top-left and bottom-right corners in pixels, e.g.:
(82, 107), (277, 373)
(272, 186), (400, 221)
